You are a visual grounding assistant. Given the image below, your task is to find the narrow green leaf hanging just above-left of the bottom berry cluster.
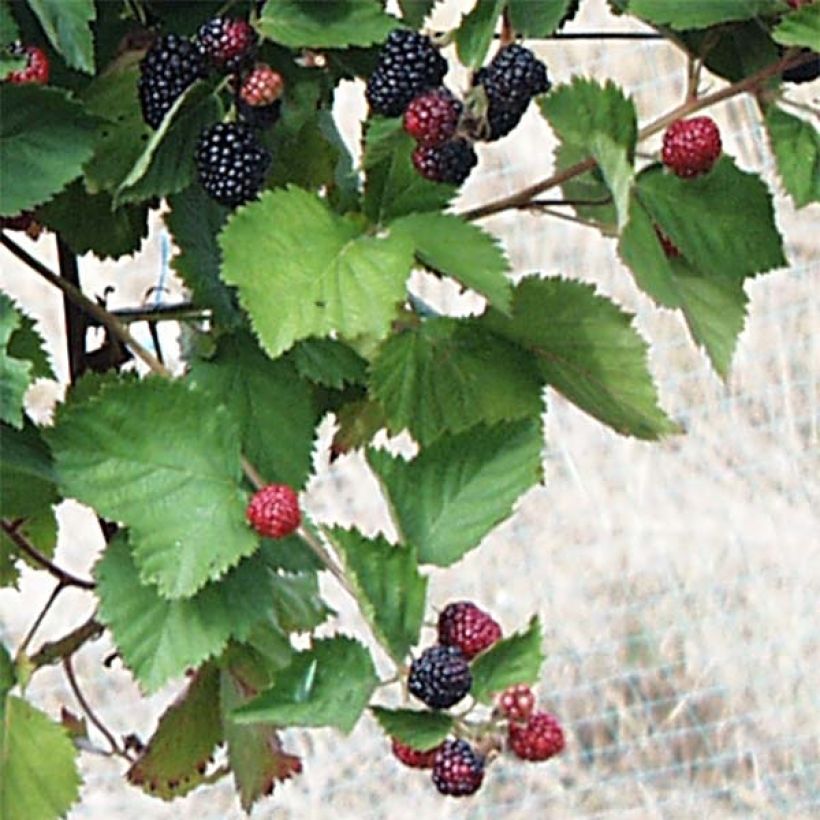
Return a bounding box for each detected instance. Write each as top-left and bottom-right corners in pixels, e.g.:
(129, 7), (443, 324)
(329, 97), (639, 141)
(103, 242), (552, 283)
(329, 527), (427, 663)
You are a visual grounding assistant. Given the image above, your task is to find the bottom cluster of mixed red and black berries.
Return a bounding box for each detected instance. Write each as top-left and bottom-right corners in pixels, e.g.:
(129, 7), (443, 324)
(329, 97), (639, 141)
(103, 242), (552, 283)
(391, 601), (565, 797)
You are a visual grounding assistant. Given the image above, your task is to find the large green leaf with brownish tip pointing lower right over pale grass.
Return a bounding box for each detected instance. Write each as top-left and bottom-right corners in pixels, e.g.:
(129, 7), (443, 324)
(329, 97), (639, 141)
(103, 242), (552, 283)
(486, 277), (679, 439)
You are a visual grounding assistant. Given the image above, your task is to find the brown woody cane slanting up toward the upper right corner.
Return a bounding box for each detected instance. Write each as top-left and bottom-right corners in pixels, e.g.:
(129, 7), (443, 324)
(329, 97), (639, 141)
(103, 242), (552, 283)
(459, 49), (811, 221)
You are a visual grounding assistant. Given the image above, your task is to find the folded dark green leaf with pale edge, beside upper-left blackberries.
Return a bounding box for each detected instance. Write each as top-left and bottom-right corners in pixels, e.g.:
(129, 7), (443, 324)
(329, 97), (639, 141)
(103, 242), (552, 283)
(114, 81), (222, 208)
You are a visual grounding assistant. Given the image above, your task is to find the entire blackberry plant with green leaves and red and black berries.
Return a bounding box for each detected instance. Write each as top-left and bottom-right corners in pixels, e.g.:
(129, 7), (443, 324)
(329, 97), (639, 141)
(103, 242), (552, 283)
(0, 0), (820, 820)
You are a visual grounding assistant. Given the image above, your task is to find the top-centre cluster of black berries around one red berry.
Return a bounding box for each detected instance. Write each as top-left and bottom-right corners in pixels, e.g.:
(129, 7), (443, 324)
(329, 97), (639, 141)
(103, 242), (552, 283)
(366, 29), (549, 185)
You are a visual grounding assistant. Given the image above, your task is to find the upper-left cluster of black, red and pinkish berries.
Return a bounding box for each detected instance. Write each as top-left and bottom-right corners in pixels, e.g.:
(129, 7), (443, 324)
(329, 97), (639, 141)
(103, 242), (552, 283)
(138, 17), (284, 207)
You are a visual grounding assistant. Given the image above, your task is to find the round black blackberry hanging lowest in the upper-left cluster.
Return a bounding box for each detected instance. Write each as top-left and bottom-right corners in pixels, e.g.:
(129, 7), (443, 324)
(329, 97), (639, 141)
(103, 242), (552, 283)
(196, 122), (271, 207)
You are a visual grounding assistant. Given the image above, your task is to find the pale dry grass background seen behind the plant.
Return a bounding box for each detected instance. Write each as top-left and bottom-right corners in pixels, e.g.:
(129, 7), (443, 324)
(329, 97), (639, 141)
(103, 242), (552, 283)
(0, 0), (820, 820)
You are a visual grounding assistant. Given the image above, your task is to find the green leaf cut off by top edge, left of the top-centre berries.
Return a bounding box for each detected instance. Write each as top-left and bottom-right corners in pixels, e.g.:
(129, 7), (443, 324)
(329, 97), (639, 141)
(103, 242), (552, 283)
(257, 0), (398, 48)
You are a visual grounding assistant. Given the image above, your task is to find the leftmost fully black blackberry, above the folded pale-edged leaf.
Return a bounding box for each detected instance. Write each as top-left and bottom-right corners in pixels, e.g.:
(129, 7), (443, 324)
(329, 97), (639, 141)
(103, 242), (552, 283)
(137, 34), (207, 128)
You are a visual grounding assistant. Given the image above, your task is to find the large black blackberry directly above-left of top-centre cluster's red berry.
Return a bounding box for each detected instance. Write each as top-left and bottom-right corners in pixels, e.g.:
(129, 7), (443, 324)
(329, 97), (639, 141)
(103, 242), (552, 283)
(365, 29), (447, 117)
